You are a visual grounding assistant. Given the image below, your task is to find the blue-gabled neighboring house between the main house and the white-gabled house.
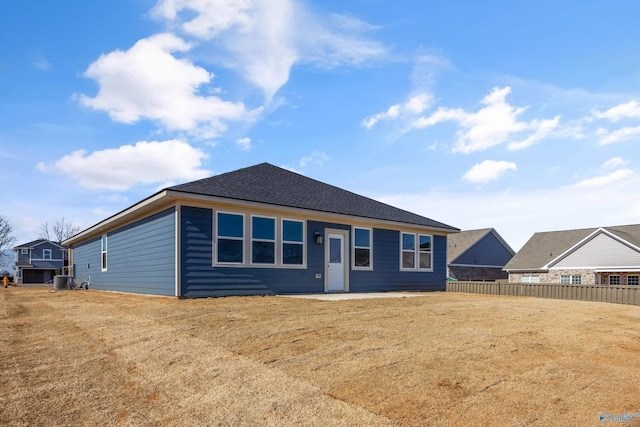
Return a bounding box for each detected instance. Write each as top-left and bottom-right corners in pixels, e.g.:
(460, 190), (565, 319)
(447, 228), (515, 280)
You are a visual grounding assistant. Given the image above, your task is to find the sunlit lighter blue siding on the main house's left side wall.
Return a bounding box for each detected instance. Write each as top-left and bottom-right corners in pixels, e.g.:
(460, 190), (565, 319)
(73, 208), (176, 296)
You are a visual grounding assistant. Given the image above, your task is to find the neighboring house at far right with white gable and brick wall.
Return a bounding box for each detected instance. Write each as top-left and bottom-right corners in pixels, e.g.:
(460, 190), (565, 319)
(504, 225), (640, 285)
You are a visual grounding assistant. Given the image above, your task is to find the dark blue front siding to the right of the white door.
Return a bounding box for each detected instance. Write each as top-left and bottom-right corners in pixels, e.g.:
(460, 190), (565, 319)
(349, 228), (447, 292)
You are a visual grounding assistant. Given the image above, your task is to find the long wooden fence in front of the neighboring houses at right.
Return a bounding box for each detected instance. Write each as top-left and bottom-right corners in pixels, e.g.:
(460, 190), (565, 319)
(447, 282), (640, 305)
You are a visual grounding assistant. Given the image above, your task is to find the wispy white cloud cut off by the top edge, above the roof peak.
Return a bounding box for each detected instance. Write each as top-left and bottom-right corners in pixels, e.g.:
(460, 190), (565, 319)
(152, 0), (387, 99)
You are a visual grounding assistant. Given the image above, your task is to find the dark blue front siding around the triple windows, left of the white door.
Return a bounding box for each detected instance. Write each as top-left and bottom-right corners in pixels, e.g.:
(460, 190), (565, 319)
(180, 206), (336, 297)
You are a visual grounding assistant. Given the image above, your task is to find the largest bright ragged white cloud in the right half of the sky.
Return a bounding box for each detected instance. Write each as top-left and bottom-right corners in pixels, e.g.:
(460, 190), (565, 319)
(413, 86), (560, 154)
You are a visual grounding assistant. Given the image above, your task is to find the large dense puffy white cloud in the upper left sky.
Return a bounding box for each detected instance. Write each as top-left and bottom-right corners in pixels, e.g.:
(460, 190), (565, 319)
(78, 33), (259, 138)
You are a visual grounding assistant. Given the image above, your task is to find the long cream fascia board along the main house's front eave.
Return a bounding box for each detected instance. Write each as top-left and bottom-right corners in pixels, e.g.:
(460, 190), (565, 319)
(166, 191), (459, 234)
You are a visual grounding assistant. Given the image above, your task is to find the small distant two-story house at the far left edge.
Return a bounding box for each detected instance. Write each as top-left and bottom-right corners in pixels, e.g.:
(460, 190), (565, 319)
(13, 239), (68, 283)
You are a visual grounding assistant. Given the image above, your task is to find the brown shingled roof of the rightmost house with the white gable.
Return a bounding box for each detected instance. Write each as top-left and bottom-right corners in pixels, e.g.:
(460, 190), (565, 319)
(504, 224), (640, 270)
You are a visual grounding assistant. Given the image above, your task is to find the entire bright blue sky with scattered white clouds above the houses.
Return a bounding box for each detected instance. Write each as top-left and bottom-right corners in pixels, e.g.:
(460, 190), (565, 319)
(0, 0), (640, 250)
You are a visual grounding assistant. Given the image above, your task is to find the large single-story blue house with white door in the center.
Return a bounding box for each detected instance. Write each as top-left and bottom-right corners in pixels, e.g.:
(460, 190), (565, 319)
(64, 163), (459, 297)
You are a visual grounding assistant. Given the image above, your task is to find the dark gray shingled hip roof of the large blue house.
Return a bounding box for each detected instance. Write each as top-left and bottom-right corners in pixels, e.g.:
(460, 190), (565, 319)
(167, 163), (458, 232)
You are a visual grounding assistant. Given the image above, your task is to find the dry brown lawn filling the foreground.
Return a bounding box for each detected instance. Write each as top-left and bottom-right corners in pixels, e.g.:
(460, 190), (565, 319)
(0, 288), (640, 426)
